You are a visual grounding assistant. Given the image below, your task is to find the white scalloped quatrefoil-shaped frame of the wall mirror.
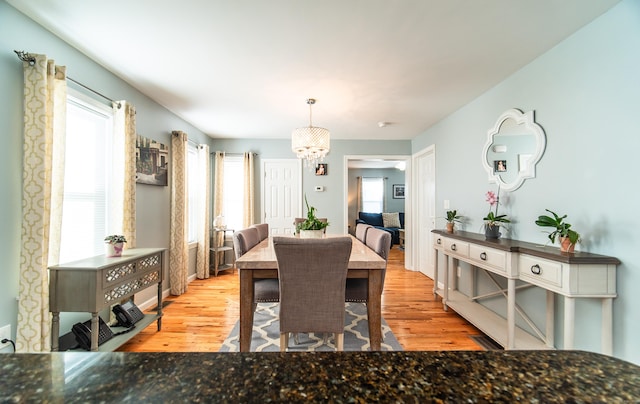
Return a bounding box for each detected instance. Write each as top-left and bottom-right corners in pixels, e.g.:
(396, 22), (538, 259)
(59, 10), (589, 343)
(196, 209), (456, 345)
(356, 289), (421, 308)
(482, 108), (547, 191)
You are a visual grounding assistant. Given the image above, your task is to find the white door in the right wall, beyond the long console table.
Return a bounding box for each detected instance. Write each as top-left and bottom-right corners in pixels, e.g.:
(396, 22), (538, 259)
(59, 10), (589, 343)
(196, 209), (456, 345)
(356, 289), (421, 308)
(413, 147), (436, 279)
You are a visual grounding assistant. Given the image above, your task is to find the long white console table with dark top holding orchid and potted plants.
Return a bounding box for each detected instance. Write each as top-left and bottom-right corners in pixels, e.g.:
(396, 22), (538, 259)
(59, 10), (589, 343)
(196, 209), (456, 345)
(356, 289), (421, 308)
(433, 230), (620, 355)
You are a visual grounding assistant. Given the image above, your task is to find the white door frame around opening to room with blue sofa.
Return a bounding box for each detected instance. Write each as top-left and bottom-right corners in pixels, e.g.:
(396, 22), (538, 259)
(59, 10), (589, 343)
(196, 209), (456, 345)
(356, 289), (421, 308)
(342, 154), (414, 269)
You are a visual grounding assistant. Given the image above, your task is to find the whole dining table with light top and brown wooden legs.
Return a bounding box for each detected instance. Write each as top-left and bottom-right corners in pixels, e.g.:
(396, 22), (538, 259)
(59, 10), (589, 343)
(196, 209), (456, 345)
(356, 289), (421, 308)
(236, 234), (387, 352)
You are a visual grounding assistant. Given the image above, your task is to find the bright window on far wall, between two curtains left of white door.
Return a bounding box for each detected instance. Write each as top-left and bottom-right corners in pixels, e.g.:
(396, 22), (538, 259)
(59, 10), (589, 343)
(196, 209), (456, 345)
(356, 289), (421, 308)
(222, 155), (244, 230)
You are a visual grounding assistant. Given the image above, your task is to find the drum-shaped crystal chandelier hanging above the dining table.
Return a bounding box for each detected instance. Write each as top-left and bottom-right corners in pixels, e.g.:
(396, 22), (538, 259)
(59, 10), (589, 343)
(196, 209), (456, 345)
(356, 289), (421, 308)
(291, 98), (330, 169)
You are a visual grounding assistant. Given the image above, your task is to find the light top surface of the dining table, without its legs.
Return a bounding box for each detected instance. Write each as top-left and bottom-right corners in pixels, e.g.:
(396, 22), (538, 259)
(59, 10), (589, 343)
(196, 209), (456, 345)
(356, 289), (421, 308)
(236, 234), (387, 270)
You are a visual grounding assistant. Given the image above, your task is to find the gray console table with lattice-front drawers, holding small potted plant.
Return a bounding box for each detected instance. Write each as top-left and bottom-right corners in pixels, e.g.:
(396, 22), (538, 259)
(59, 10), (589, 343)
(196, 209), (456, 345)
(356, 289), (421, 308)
(49, 248), (165, 351)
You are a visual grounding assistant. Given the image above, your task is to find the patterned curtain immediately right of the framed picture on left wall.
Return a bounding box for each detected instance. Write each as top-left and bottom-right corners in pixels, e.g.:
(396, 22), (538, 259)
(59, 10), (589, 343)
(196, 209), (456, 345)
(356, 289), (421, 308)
(169, 131), (189, 296)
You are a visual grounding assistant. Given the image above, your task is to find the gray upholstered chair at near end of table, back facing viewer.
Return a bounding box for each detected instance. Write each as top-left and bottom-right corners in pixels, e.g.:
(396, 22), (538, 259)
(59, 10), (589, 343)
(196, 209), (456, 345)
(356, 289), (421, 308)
(273, 237), (351, 351)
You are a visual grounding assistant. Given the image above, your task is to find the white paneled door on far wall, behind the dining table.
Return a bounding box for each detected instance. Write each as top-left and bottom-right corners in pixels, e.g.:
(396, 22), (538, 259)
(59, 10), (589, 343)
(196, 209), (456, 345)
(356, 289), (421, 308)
(261, 159), (302, 235)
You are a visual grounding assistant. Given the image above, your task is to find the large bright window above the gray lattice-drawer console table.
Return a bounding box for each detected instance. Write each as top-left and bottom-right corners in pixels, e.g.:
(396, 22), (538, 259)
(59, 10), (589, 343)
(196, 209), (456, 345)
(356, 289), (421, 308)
(60, 89), (113, 262)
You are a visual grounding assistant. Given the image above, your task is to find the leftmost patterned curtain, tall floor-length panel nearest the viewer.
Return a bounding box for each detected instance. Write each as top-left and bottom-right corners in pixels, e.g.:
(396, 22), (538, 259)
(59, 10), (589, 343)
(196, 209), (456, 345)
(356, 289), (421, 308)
(16, 54), (67, 352)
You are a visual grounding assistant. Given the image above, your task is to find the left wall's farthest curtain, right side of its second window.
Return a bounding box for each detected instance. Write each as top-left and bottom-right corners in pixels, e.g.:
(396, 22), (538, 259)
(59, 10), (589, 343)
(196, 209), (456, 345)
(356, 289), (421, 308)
(196, 145), (211, 279)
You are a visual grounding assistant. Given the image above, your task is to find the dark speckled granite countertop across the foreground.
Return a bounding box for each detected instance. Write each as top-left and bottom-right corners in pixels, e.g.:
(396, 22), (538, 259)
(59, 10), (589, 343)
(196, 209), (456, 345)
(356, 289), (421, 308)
(0, 351), (640, 403)
